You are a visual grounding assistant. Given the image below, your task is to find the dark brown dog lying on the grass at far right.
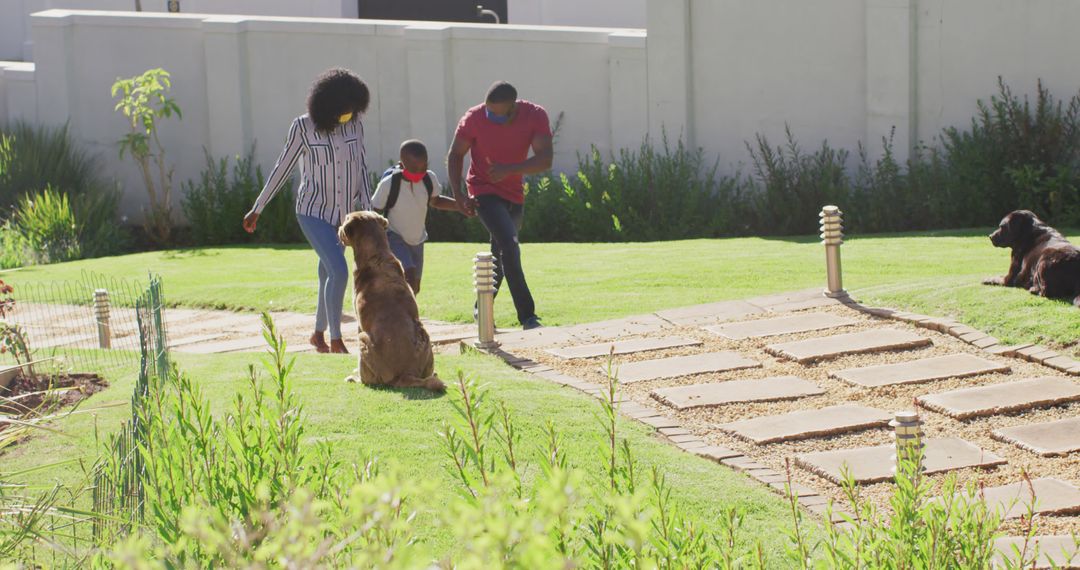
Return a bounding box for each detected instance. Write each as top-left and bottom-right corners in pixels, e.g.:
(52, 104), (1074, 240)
(983, 209), (1080, 307)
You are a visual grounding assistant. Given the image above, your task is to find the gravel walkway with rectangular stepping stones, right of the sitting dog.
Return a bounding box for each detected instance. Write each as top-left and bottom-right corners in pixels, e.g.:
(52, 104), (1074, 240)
(479, 289), (1080, 561)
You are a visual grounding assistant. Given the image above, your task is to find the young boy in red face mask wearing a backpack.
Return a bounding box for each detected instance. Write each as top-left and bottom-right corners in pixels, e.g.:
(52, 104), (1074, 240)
(372, 139), (459, 294)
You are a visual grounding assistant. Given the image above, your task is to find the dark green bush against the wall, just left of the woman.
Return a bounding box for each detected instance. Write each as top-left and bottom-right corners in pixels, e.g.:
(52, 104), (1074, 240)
(183, 148), (303, 245)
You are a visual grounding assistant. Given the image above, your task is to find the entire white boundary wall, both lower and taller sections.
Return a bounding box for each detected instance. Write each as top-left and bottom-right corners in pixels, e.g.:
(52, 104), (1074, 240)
(0, 0), (1080, 220)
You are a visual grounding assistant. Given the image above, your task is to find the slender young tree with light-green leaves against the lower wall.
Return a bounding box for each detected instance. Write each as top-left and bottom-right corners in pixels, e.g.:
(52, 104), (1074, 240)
(111, 68), (183, 244)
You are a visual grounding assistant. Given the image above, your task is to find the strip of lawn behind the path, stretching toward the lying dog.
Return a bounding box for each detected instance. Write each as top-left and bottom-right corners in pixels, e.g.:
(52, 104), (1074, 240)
(3, 229), (1080, 355)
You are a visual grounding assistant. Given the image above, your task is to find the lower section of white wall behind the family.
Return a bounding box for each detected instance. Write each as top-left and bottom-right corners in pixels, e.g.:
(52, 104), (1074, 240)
(10, 11), (646, 216)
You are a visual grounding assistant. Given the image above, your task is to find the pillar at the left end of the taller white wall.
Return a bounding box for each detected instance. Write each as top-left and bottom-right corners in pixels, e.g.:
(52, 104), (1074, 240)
(646, 0), (694, 148)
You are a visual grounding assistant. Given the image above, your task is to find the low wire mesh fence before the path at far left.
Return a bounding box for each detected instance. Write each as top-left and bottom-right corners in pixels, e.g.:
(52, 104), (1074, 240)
(0, 271), (159, 374)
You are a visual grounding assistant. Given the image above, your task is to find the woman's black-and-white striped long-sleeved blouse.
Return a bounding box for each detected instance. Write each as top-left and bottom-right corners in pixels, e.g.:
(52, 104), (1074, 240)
(254, 114), (372, 226)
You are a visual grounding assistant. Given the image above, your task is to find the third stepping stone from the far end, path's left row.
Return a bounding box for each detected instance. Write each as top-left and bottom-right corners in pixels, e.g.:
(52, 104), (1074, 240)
(651, 376), (825, 410)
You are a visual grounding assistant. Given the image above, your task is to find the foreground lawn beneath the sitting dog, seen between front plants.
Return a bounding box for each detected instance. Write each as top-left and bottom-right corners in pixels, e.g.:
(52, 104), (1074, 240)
(0, 347), (803, 557)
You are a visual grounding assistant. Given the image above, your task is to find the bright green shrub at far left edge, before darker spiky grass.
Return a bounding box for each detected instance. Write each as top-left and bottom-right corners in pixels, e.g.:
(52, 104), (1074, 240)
(2, 188), (81, 267)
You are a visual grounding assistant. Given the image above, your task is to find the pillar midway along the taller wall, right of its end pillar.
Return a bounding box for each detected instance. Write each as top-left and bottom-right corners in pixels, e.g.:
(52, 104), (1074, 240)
(864, 0), (917, 163)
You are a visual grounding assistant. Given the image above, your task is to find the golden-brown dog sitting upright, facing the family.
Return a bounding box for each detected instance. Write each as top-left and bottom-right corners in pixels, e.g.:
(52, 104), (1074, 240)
(338, 212), (446, 391)
